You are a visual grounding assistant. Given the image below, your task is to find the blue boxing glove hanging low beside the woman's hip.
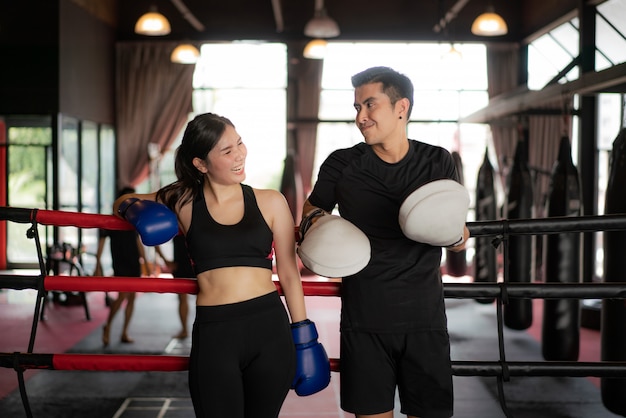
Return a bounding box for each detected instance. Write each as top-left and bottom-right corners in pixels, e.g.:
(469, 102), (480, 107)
(291, 319), (330, 396)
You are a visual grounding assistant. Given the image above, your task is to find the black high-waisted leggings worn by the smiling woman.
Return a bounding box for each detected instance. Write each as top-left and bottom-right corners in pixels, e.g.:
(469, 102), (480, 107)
(189, 292), (295, 418)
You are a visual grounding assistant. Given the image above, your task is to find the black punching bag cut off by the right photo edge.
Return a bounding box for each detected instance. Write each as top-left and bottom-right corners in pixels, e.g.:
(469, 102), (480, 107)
(600, 128), (626, 416)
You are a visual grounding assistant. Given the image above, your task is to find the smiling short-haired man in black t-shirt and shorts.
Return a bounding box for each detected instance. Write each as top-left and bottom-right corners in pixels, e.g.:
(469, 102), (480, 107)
(303, 67), (469, 418)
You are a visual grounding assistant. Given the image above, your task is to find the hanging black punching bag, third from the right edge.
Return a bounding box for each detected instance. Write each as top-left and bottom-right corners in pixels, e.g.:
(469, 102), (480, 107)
(504, 137), (533, 330)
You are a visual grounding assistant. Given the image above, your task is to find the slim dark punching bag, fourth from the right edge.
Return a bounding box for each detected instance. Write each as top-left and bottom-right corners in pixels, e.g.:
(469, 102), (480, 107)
(474, 149), (498, 303)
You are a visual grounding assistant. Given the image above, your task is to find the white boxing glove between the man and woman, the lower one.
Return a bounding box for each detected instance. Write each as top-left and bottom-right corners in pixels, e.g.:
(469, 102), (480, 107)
(297, 210), (371, 278)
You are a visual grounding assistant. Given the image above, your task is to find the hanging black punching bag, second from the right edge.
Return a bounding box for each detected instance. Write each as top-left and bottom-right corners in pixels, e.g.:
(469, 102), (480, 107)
(541, 137), (582, 361)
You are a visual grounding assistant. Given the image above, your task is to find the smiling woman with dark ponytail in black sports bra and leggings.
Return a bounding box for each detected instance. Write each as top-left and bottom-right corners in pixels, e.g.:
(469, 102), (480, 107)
(113, 113), (330, 418)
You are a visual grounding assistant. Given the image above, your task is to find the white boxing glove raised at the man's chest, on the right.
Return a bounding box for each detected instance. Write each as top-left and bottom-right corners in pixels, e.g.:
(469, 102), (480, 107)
(398, 179), (470, 247)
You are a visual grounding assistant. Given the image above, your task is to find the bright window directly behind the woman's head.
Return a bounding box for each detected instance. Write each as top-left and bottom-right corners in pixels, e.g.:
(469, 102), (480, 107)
(193, 42), (287, 190)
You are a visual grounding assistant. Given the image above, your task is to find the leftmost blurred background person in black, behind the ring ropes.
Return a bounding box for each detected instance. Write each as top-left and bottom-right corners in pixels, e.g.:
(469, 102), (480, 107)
(93, 187), (150, 347)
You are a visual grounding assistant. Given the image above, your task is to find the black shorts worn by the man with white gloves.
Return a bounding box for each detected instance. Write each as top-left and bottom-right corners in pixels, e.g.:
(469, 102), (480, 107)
(340, 331), (454, 418)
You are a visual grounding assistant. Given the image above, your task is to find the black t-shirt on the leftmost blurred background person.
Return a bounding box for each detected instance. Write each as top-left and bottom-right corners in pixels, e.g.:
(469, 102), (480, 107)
(99, 229), (141, 277)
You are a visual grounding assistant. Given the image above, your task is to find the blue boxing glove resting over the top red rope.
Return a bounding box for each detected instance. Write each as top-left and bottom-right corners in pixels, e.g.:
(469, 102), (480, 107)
(117, 197), (178, 246)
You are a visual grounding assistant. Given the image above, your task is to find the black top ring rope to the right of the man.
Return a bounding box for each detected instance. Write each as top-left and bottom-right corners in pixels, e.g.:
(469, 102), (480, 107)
(467, 214), (626, 237)
